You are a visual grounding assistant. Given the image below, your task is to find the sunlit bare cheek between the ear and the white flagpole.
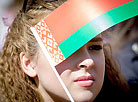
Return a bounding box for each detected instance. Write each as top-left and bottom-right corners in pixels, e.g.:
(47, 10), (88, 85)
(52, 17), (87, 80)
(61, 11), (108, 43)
(36, 55), (66, 95)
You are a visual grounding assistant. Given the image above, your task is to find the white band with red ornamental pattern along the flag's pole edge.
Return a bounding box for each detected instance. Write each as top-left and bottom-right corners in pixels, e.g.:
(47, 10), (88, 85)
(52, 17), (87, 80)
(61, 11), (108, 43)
(35, 20), (65, 65)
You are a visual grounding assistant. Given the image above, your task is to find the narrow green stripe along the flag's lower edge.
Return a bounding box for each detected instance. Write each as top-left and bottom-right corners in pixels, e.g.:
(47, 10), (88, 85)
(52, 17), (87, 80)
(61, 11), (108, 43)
(59, 0), (138, 58)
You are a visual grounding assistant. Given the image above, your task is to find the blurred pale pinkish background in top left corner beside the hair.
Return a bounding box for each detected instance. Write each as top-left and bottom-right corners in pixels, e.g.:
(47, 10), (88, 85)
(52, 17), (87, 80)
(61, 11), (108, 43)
(0, 0), (24, 50)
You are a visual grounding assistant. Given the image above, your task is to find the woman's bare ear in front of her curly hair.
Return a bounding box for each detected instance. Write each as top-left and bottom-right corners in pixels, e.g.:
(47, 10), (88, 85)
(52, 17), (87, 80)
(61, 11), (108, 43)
(20, 52), (37, 77)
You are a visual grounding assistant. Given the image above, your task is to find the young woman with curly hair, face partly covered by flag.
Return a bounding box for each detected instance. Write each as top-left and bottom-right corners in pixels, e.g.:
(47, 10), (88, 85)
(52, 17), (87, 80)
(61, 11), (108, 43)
(0, 0), (126, 102)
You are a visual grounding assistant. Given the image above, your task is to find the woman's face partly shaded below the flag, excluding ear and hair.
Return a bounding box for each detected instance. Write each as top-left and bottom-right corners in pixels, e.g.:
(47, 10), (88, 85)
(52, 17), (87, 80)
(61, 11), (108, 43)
(36, 35), (105, 102)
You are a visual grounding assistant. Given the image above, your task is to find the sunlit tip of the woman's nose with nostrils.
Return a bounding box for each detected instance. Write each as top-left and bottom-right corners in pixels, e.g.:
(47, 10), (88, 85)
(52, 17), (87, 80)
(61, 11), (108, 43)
(77, 59), (94, 69)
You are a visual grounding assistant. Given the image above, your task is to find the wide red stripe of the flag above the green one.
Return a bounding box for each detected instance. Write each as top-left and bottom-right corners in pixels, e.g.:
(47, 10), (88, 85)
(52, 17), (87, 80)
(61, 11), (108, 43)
(44, 0), (132, 44)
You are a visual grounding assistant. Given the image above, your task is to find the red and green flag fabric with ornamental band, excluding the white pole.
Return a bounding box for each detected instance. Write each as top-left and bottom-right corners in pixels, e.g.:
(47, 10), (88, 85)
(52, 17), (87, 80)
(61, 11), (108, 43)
(31, 0), (138, 65)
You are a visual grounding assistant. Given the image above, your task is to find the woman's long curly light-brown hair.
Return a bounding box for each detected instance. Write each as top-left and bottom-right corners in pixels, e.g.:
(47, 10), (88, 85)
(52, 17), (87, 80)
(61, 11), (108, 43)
(0, 0), (128, 102)
